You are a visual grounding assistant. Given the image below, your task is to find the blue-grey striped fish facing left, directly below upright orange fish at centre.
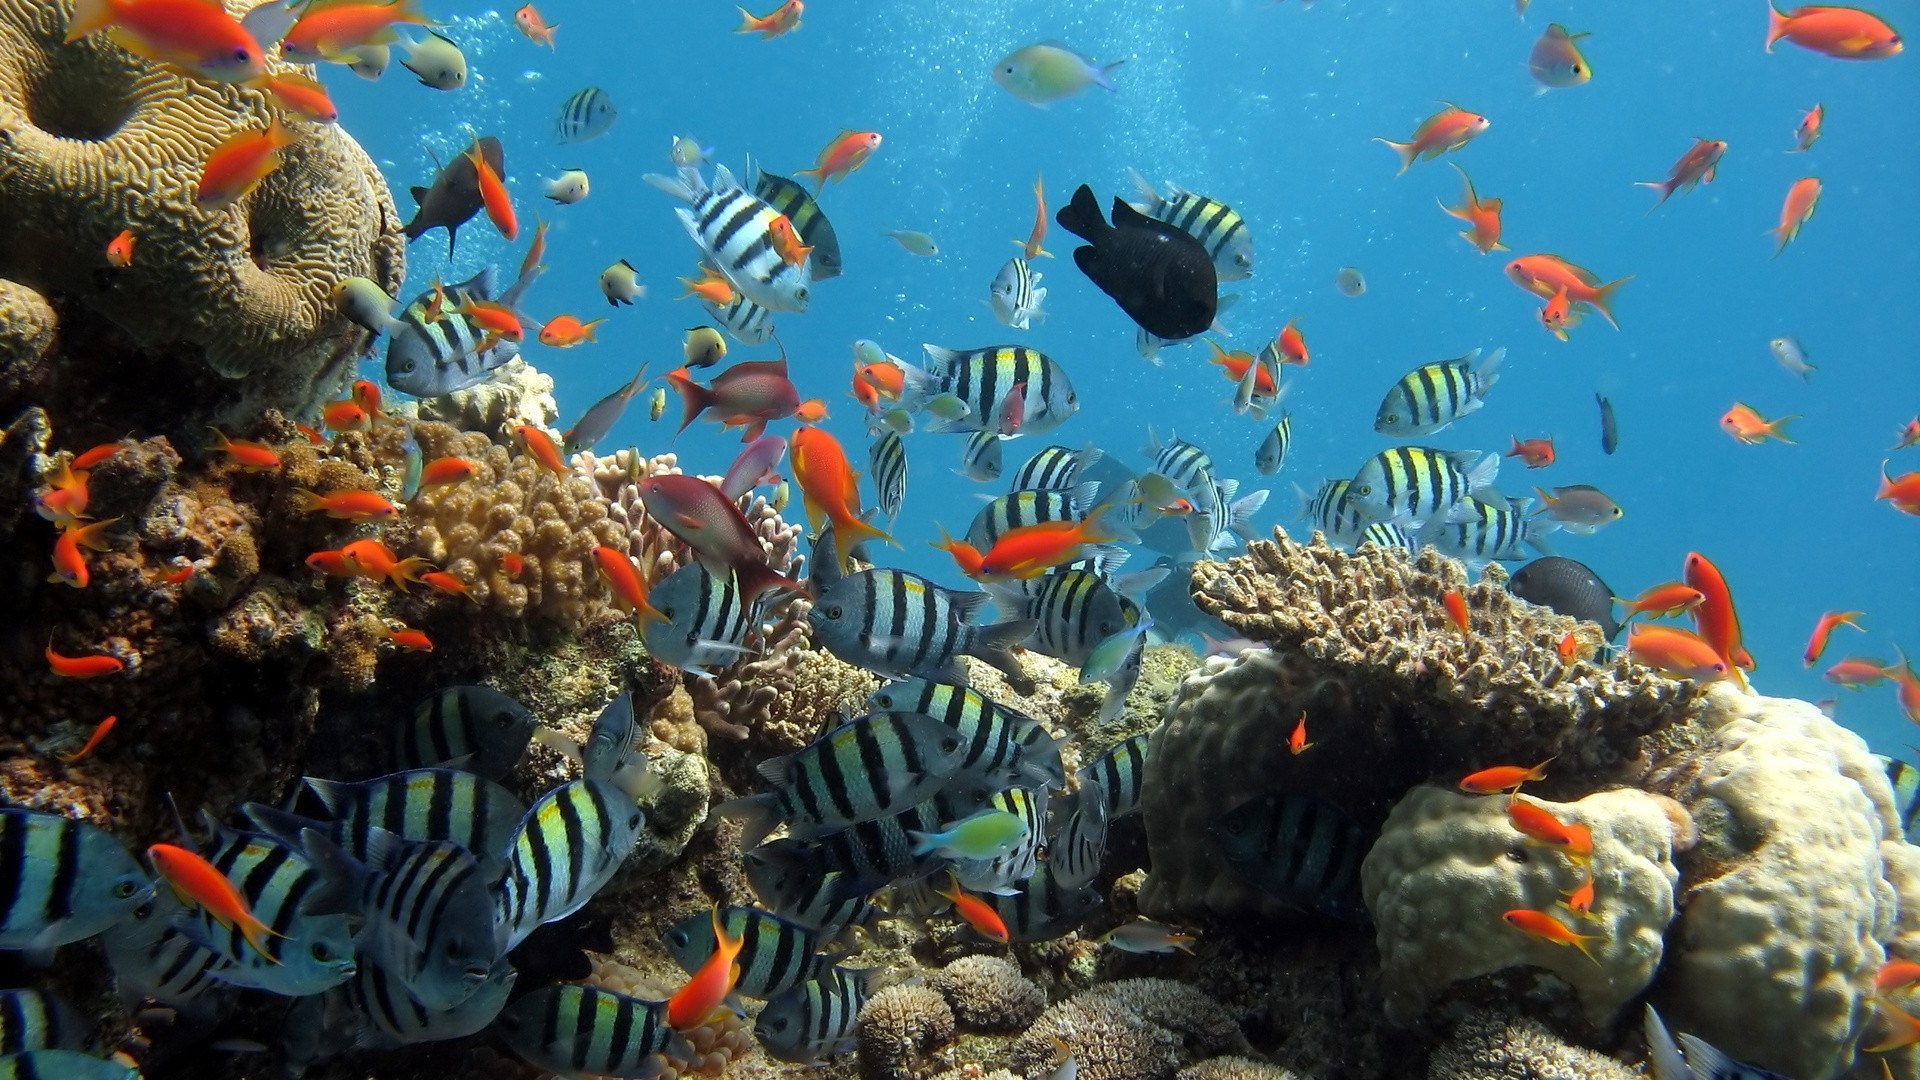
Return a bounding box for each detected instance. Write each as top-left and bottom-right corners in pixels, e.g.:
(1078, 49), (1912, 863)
(806, 567), (1033, 684)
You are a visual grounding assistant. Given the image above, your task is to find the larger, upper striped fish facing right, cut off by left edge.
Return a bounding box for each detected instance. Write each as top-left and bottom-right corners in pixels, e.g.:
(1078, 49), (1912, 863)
(0, 809), (154, 949)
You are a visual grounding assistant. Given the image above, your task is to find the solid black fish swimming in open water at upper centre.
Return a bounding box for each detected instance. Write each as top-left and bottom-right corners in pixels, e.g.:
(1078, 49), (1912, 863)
(1054, 184), (1219, 338)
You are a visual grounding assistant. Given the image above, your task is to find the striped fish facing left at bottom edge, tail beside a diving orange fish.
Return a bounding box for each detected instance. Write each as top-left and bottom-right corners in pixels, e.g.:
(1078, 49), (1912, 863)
(495, 986), (699, 1076)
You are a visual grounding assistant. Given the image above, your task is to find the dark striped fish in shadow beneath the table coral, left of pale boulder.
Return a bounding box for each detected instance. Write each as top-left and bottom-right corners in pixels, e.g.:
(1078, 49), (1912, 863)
(1208, 792), (1373, 919)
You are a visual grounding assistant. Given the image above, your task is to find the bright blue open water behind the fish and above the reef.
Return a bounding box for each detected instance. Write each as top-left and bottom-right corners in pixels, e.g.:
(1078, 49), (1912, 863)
(337, 0), (1920, 751)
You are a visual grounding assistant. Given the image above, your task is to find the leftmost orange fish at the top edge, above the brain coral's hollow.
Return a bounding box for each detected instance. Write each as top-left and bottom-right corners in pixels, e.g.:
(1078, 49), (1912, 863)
(65, 0), (267, 83)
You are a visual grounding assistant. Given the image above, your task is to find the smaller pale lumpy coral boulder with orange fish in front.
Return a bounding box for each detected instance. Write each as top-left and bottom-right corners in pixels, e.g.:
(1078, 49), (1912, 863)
(1361, 786), (1678, 1026)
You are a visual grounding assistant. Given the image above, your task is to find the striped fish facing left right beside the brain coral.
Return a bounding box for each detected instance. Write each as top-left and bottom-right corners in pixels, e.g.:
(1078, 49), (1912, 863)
(386, 265), (541, 398)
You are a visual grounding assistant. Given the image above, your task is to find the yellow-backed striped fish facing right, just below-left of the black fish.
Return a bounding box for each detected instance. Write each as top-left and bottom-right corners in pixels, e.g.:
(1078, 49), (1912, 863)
(904, 344), (1079, 434)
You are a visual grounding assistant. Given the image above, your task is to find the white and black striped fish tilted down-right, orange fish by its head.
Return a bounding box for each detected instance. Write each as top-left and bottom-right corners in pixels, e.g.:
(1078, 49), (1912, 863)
(641, 165), (808, 311)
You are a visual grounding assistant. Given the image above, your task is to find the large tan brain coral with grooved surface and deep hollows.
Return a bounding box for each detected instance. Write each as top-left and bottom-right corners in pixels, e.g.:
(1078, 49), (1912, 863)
(0, 0), (405, 427)
